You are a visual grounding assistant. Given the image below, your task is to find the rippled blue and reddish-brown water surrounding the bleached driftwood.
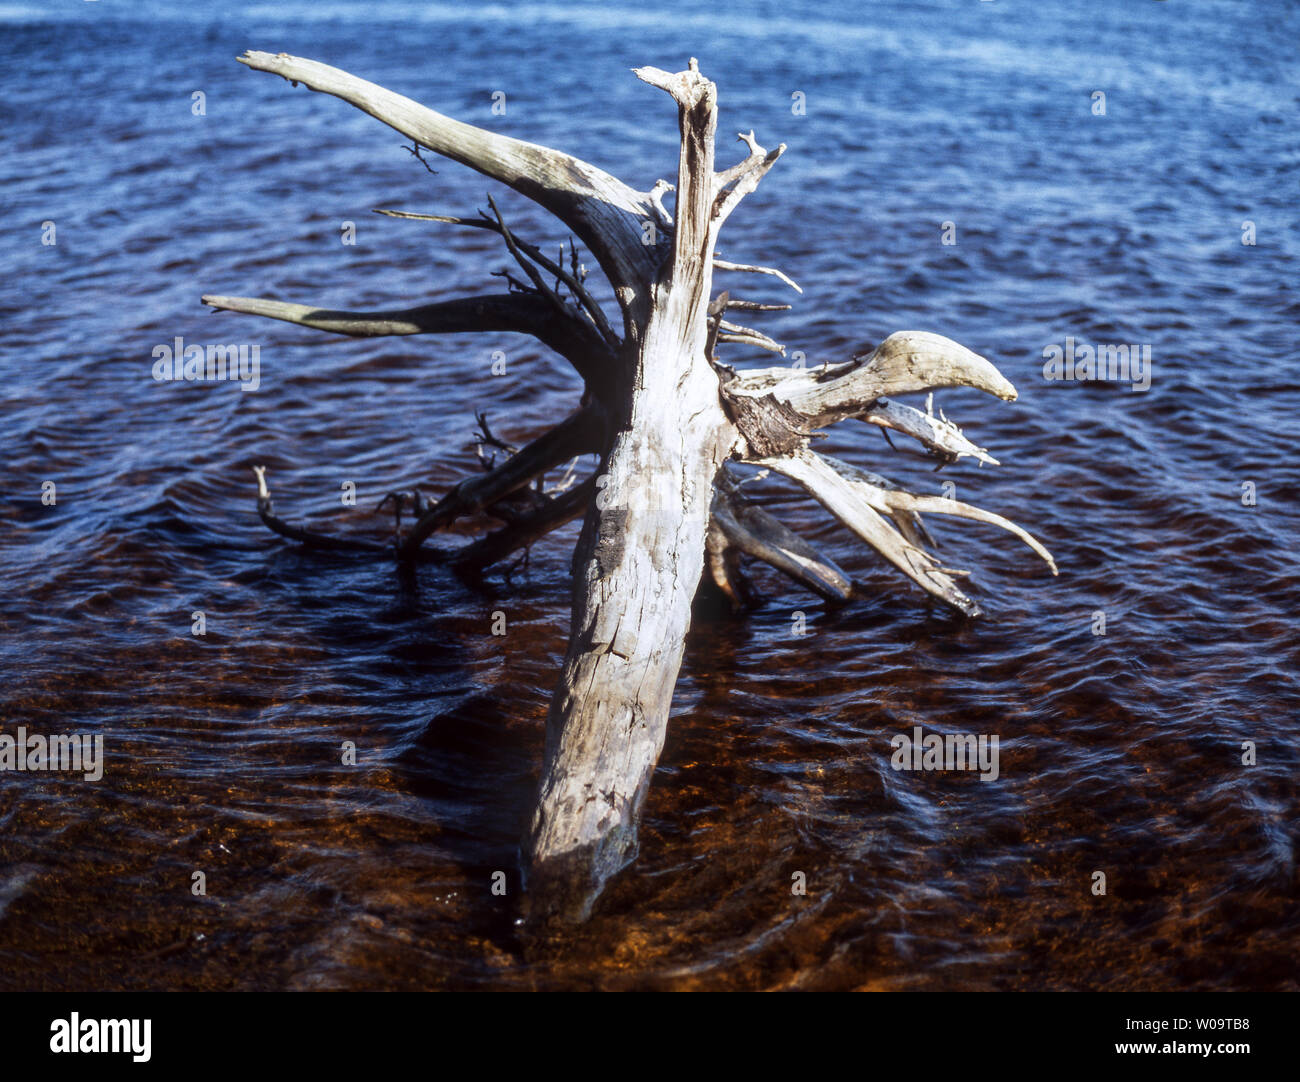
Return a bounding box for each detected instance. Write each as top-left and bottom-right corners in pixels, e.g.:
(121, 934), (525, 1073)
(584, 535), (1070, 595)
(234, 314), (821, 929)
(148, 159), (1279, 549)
(0, 0), (1300, 988)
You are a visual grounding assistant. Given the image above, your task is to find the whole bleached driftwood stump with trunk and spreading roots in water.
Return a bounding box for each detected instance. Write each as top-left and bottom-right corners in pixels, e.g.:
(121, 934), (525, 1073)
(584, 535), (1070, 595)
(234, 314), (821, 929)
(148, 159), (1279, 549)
(203, 52), (1056, 918)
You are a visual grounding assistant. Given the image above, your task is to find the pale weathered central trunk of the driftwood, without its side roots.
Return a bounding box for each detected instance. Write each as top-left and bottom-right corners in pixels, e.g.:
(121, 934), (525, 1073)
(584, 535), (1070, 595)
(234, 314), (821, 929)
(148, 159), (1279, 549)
(527, 62), (736, 917)
